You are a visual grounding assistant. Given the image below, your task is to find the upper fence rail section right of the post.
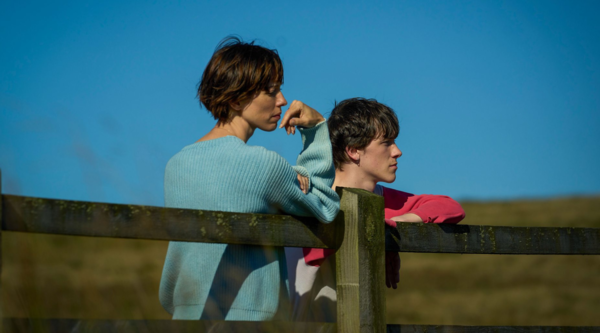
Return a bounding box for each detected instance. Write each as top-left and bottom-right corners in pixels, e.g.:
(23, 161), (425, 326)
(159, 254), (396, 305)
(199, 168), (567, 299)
(386, 223), (600, 254)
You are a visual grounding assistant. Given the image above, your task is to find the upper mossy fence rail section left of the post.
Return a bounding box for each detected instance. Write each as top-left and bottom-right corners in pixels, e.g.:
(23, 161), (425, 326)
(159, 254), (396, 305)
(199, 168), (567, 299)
(0, 195), (343, 249)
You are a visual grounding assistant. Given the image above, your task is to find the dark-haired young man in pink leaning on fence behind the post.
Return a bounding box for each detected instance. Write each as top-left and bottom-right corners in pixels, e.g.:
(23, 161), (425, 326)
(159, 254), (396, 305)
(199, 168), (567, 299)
(286, 98), (465, 321)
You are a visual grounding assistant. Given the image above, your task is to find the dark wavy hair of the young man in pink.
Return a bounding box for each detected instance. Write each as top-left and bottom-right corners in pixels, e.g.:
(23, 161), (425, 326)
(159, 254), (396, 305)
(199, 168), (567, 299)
(327, 98), (400, 170)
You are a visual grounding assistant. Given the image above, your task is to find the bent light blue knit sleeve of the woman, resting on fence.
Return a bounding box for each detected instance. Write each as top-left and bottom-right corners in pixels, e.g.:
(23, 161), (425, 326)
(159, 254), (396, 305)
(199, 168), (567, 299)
(265, 122), (340, 223)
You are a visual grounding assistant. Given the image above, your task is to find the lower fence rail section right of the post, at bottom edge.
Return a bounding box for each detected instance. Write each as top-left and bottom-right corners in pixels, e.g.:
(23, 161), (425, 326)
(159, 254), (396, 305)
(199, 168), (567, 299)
(387, 325), (600, 333)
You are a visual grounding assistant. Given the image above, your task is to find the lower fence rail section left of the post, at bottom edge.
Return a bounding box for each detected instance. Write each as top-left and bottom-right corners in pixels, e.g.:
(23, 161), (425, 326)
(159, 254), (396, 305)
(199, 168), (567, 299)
(2, 318), (336, 333)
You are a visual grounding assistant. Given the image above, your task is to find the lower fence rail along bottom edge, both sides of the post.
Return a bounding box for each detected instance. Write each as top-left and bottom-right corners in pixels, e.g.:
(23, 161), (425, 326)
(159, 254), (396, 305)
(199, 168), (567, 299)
(2, 318), (600, 333)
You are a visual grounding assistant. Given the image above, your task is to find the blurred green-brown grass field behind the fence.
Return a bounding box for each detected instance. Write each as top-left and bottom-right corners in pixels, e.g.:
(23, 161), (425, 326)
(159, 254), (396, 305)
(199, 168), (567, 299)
(1, 197), (600, 326)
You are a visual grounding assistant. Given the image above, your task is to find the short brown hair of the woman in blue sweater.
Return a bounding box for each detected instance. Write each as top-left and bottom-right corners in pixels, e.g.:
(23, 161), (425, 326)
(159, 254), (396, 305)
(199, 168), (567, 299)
(197, 36), (283, 123)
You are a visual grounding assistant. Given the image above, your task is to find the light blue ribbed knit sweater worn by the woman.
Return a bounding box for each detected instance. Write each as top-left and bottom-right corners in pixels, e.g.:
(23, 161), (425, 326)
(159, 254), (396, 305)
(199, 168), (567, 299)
(159, 122), (339, 320)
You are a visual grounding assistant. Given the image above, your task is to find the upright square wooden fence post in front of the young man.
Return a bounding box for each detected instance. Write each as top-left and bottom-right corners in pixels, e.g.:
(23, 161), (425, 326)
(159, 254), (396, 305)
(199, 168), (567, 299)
(336, 187), (386, 333)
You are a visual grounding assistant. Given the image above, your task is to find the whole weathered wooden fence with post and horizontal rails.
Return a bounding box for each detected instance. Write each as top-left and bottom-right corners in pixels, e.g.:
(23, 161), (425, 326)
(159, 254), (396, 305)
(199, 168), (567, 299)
(0, 170), (600, 333)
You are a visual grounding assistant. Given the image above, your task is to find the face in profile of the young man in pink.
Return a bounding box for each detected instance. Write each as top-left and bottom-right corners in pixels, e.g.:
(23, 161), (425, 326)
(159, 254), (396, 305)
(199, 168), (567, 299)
(359, 138), (402, 183)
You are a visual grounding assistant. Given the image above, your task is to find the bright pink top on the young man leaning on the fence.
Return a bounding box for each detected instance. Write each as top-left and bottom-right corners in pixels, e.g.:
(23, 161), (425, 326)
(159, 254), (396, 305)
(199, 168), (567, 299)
(302, 187), (465, 266)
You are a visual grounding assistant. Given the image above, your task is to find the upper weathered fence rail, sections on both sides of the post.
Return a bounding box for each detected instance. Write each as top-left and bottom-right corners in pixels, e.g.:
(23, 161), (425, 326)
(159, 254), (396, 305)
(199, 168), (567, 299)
(2, 195), (600, 255)
